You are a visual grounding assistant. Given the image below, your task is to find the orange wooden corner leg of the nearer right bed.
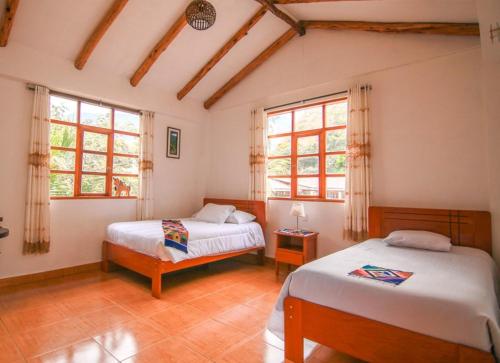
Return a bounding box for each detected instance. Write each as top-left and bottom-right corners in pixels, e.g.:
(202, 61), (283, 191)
(283, 297), (304, 363)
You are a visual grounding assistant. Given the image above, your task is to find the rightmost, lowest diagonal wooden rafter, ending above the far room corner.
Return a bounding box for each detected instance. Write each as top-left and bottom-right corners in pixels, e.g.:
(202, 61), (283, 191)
(204, 28), (296, 109)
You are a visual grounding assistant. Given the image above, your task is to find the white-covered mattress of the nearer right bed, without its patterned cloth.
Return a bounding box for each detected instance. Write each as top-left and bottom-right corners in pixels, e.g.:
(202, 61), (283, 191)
(268, 239), (500, 351)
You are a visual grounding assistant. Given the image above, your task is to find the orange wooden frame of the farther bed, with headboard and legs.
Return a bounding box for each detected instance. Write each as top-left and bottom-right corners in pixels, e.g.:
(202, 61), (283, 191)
(102, 198), (266, 298)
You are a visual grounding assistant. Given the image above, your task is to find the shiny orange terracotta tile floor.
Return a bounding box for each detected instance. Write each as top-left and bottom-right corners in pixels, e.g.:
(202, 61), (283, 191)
(0, 261), (364, 363)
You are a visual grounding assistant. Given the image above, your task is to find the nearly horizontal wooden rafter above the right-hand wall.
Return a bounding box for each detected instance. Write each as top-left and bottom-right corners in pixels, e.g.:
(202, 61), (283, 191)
(304, 20), (479, 36)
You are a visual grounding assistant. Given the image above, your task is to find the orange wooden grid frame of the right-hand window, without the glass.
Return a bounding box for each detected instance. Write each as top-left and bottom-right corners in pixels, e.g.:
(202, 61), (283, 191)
(266, 97), (349, 203)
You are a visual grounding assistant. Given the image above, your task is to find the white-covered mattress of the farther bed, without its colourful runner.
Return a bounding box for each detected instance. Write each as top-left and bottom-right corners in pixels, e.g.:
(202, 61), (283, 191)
(107, 218), (265, 262)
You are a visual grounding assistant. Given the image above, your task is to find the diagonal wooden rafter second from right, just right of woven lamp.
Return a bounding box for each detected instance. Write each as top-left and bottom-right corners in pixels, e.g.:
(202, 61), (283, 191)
(177, 6), (267, 100)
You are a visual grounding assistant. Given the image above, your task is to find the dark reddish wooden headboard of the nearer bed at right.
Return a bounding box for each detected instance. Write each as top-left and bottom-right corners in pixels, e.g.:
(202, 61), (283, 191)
(368, 207), (491, 255)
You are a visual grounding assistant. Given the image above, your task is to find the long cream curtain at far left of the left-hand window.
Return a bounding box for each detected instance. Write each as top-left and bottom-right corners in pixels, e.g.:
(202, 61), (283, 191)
(23, 86), (50, 254)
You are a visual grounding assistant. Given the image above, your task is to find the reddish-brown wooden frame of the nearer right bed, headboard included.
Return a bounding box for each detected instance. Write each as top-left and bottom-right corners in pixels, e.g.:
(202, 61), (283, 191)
(284, 207), (495, 363)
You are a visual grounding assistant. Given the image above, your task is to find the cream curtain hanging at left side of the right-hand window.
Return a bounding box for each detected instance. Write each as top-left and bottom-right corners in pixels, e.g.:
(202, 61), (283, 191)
(248, 108), (267, 201)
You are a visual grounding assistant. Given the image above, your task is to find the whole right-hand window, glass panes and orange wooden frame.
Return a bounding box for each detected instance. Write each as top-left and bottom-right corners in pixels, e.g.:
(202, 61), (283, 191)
(267, 98), (348, 201)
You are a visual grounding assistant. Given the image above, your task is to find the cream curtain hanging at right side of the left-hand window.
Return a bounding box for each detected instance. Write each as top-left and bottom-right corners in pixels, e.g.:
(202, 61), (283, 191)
(137, 111), (155, 220)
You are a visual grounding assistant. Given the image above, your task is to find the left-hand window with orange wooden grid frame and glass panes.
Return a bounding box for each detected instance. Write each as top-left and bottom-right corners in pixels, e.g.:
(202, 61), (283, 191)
(50, 94), (140, 199)
